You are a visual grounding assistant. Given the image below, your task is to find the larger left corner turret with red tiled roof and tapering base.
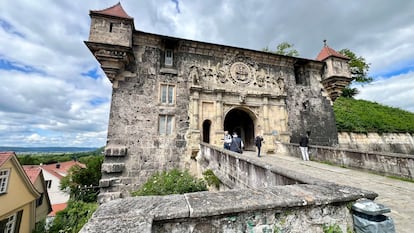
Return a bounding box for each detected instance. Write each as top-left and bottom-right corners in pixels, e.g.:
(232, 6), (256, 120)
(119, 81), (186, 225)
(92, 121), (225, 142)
(85, 3), (135, 88)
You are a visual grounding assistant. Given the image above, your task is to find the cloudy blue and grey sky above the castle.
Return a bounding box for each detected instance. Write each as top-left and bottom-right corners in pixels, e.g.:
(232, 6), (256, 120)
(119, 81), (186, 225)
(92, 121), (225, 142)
(0, 0), (414, 147)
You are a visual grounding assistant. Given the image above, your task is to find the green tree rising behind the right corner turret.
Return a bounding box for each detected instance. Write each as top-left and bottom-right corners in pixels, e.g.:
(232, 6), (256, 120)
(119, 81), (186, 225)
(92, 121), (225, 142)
(339, 49), (373, 98)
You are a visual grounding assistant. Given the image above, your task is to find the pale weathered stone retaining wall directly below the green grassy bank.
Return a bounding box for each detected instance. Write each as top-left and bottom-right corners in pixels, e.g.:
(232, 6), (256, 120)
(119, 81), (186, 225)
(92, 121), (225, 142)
(338, 133), (414, 155)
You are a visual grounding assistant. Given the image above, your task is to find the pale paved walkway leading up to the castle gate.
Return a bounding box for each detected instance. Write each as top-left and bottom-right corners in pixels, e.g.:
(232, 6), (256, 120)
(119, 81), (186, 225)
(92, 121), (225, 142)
(243, 151), (414, 233)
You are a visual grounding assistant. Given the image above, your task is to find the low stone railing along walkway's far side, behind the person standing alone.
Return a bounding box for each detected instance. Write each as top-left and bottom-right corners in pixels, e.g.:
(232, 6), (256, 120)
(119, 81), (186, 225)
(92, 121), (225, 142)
(280, 143), (414, 179)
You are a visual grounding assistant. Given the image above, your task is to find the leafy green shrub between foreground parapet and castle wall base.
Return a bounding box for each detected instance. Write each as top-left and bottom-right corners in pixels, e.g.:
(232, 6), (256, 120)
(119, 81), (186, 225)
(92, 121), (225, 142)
(131, 169), (207, 196)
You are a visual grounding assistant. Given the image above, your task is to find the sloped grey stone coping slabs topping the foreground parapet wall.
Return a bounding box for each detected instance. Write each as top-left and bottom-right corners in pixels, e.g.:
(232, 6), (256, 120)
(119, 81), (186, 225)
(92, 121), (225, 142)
(80, 183), (377, 233)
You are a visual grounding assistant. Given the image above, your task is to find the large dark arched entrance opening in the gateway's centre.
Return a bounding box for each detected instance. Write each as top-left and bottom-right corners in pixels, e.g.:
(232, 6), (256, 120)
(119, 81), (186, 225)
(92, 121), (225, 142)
(224, 108), (255, 150)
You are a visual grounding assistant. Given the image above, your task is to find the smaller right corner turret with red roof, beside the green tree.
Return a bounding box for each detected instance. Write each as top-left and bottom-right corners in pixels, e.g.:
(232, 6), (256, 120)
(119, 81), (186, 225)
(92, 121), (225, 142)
(316, 40), (352, 101)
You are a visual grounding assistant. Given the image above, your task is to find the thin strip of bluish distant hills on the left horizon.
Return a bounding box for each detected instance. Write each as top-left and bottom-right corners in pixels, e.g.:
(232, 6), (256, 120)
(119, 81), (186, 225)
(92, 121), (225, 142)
(0, 146), (98, 154)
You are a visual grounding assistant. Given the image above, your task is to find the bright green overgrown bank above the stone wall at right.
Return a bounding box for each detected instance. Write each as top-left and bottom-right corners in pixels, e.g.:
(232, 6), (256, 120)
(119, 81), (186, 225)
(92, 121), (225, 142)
(333, 97), (414, 134)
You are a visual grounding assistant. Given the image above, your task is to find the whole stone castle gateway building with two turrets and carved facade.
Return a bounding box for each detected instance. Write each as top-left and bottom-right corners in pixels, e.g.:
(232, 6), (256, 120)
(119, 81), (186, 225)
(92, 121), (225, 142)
(85, 3), (352, 201)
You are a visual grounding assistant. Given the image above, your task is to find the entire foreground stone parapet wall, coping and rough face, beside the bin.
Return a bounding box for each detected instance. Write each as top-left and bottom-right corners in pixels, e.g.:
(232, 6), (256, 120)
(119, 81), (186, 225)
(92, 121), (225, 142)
(80, 183), (376, 233)
